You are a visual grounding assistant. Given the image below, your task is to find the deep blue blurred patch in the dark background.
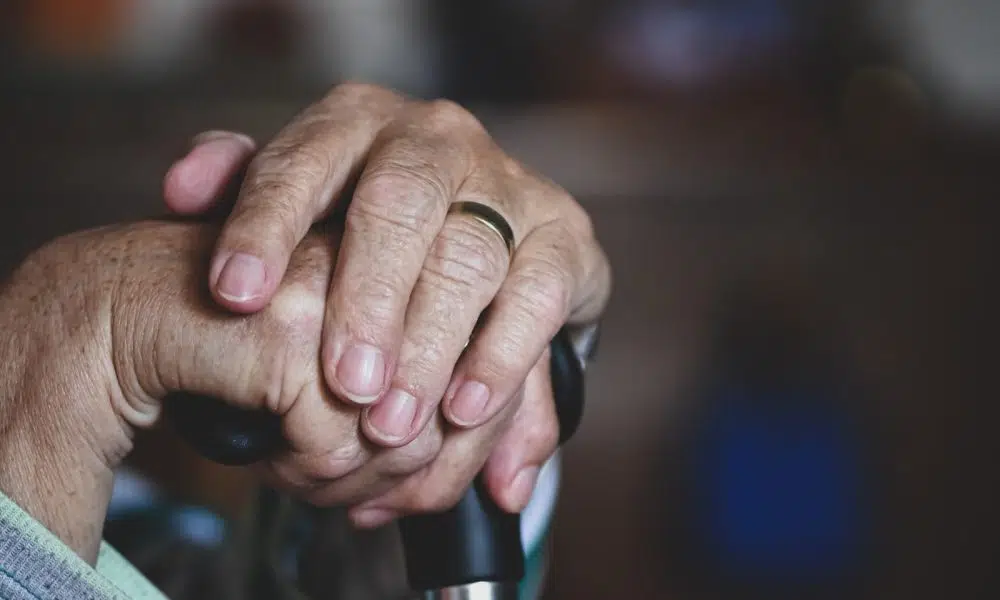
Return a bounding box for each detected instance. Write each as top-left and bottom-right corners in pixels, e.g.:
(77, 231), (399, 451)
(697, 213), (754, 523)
(695, 389), (865, 580)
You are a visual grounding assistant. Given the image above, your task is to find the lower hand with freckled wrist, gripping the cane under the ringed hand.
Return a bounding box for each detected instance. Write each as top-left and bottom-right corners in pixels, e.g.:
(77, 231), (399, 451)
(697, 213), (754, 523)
(0, 222), (555, 561)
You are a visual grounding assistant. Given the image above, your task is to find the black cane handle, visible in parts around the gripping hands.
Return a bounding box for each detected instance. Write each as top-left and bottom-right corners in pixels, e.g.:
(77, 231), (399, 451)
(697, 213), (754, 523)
(164, 330), (584, 591)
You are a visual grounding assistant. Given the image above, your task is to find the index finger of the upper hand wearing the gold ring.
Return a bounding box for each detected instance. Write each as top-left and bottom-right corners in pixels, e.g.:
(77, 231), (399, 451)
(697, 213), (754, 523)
(209, 84), (403, 312)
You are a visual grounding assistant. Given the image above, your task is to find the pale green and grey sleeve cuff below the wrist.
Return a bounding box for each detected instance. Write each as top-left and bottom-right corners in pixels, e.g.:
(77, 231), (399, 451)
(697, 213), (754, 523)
(0, 493), (166, 600)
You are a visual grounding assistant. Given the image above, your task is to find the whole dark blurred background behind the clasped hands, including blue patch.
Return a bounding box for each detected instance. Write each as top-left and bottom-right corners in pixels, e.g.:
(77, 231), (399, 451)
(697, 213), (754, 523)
(0, 0), (1000, 600)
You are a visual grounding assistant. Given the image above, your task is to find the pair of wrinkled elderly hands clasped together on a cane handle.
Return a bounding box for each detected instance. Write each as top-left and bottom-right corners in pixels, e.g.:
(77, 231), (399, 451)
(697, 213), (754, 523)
(0, 84), (610, 559)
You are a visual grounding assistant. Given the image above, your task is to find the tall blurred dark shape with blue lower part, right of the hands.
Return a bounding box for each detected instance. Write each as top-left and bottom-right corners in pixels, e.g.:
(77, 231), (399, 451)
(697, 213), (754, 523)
(667, 283), (880, 600)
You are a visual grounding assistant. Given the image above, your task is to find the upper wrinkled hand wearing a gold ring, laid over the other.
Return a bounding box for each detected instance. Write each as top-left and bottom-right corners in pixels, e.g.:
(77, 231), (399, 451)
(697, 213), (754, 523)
(164, 84), (611, 512)
